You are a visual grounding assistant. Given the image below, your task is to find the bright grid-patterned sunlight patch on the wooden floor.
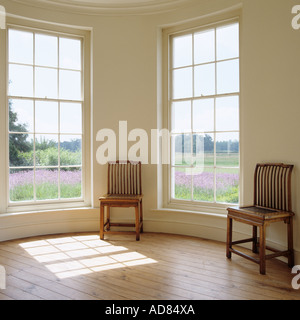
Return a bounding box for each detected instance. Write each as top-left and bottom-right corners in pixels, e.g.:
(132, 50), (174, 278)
(20, 235), (157, 279)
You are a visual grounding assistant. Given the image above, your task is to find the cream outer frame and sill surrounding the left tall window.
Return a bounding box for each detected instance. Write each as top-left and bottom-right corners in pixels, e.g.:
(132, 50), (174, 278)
(0, 17), (91, 213)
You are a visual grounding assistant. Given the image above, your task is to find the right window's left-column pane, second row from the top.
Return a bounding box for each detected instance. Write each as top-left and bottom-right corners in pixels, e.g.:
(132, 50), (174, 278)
(173, 68), (193, 99)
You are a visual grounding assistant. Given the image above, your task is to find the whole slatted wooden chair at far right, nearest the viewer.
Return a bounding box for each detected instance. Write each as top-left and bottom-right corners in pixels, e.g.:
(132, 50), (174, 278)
(226, 163), (294, 274)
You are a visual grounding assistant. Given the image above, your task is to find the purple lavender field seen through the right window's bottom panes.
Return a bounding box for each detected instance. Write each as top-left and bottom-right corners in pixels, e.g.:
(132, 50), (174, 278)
(174, 171), (239, 203)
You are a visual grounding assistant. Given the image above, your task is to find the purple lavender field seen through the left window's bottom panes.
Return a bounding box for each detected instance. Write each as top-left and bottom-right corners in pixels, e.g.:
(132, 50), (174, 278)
(9, 169), (81, 201)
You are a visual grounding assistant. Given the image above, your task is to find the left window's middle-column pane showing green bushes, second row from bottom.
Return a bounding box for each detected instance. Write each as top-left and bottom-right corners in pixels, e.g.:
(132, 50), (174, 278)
(35, 134), (58, 167)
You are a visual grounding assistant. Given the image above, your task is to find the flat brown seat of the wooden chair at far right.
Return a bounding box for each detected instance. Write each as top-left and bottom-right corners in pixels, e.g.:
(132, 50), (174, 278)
(228, 205), (295, 221)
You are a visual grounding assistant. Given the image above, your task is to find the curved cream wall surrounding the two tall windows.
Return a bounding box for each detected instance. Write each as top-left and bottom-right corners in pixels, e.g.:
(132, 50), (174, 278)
(0, 0), (300, 264)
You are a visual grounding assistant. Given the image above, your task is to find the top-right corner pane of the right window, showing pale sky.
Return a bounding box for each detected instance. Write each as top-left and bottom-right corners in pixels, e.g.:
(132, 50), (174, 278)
(217, 23), (239, 60)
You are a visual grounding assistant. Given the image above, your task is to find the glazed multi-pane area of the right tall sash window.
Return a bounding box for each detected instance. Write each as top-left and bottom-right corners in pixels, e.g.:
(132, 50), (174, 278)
(169, 22), (239, 203)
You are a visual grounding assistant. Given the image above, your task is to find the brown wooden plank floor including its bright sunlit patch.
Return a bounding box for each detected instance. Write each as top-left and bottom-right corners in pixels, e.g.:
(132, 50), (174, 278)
(0, 233), (300, 300)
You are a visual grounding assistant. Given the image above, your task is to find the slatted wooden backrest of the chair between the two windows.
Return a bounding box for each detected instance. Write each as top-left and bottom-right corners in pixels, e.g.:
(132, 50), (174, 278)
(107, 161), (142, 195)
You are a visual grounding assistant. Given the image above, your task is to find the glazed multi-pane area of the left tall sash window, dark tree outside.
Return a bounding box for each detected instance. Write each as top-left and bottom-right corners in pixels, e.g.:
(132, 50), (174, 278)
(8, 27), (83, 203)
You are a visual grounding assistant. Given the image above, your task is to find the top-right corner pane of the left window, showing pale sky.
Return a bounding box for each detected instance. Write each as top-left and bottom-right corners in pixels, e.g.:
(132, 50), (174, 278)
(59, 38), (81, 70)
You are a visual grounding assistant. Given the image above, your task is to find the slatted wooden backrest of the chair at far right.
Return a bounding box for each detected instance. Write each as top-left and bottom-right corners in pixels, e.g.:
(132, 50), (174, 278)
(254, 163), (294, 212)
